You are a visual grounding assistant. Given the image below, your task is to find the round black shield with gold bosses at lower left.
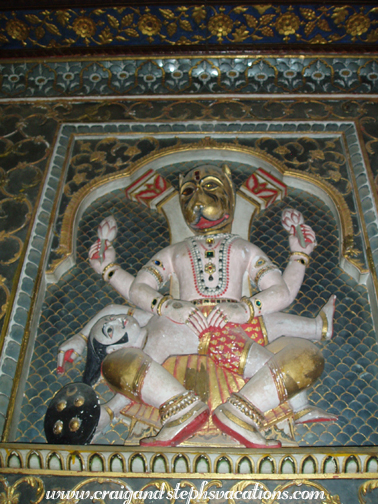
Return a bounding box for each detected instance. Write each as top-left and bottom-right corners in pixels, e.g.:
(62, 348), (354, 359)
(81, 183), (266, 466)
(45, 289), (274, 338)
(45, 383), (101, 444)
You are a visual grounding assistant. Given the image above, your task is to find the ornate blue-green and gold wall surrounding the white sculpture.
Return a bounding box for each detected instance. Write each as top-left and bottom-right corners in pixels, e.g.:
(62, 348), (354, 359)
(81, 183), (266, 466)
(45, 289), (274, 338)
(0, 4), (378, 492)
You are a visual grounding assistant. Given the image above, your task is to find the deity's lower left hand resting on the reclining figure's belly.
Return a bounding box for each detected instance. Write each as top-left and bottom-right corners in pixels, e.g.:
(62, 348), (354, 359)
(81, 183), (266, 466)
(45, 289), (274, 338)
(160, 299), (208, 336)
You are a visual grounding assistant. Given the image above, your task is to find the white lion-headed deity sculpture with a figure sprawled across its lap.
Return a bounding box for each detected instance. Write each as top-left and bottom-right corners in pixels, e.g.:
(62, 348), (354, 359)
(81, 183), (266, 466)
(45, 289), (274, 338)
(53, 165), (335, 448)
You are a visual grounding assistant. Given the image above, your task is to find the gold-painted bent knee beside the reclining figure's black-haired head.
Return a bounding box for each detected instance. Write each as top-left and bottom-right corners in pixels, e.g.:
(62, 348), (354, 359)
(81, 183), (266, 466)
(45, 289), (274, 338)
(102, 348), (152, 402)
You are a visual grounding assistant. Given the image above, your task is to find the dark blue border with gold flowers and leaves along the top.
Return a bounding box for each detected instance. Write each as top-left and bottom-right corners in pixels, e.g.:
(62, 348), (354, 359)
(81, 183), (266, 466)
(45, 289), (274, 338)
(0, 3), (378, 52)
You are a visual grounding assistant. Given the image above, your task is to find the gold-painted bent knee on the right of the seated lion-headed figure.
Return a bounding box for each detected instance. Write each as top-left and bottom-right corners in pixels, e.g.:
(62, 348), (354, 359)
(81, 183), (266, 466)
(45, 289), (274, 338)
(267, 338), (324, 401)
